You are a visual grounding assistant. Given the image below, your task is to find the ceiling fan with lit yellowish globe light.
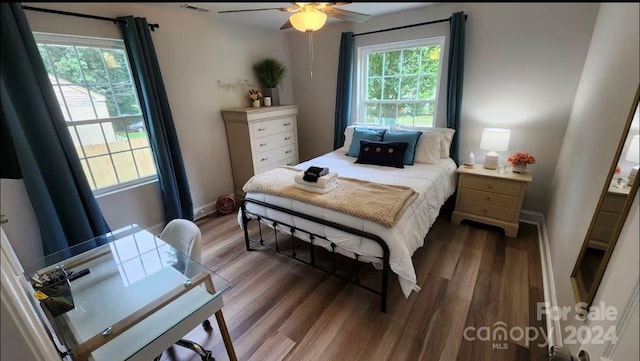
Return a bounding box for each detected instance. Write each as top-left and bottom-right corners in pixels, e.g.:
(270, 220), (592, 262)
(218, 2), (371, 32)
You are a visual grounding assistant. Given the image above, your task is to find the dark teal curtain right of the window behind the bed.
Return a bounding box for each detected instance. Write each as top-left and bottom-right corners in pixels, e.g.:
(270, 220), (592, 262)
(447, 11), (466, 164)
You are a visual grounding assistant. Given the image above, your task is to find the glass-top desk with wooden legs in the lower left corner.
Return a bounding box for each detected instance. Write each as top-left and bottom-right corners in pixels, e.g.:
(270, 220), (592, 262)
(24, 225), (236, 361)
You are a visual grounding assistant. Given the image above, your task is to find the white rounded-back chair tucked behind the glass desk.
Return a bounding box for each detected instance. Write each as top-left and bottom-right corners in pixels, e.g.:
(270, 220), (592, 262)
(156, 219), (214, 361)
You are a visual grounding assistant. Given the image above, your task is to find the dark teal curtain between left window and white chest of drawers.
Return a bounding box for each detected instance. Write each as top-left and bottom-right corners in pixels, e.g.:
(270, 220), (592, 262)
(118, 16), (192, 219)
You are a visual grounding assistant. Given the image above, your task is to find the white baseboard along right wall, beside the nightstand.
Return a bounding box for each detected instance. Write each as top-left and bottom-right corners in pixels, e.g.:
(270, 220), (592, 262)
(520, 210), (562, 348)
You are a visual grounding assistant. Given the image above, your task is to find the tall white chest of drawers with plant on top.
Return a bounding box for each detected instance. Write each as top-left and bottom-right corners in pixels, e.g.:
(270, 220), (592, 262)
(222, 105), (298, 196)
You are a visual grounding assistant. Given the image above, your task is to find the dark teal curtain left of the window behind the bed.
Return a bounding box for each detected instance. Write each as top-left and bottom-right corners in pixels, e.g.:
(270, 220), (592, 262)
(333, 32), (355, 150)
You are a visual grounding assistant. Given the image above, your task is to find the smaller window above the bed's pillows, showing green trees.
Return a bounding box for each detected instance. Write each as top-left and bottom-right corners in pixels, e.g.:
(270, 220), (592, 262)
(356, 37), (444, 126)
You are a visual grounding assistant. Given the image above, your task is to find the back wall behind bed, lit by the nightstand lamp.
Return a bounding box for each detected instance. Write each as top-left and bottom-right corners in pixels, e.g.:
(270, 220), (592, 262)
(289, 3), (599, 212)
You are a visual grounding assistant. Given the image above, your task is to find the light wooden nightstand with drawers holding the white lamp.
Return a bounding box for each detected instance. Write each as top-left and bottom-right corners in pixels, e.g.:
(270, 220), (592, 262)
(451, 164), (533, 237)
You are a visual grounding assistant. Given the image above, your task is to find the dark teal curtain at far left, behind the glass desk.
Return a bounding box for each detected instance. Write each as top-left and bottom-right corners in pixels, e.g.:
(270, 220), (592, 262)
(0, 3), (110, 254)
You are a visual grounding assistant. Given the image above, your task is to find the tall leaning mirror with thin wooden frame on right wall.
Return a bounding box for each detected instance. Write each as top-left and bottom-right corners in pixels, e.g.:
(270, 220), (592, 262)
(571, 88), (640, 308)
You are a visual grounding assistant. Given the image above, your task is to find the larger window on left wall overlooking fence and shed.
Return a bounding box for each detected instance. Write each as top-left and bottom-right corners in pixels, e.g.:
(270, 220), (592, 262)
(34, 33), (157, 195)
